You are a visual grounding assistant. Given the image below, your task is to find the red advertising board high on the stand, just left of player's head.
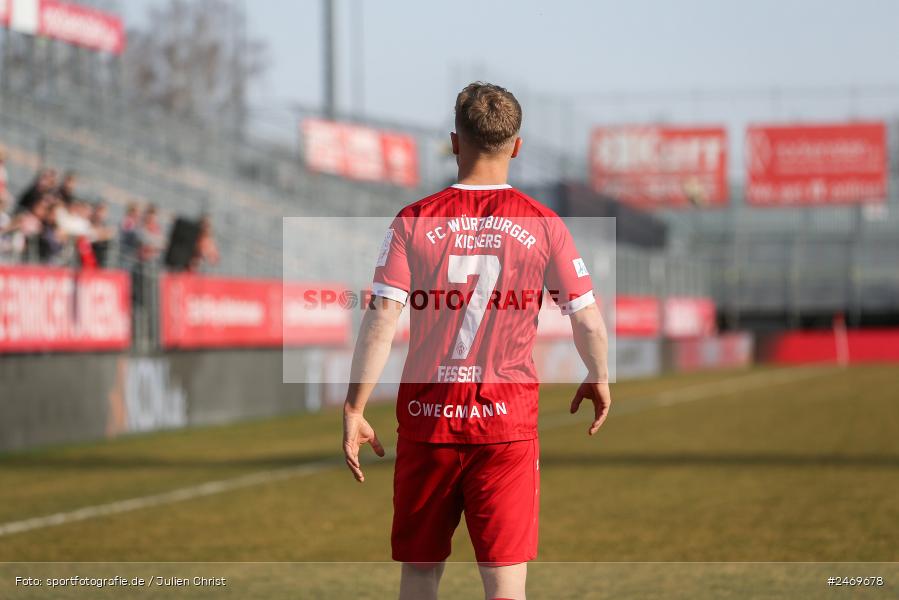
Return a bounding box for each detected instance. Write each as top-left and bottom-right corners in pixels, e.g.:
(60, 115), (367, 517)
(303, 119), (418, 187)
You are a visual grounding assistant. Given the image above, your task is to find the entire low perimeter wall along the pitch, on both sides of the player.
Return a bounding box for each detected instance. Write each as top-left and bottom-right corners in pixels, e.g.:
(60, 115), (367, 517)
(0, 334), (752, 451)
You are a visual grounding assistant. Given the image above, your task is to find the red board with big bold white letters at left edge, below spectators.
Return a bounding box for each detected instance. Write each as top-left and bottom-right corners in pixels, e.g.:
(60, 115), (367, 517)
(0, 267), (131, 353)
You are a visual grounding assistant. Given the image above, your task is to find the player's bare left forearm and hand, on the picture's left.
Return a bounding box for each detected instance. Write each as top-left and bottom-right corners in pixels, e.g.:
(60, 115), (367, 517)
(343, 296), (403, 483)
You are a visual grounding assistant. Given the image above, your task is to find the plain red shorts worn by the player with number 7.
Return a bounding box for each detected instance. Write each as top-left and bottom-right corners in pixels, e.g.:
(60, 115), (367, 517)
(391, 438), (540, 566)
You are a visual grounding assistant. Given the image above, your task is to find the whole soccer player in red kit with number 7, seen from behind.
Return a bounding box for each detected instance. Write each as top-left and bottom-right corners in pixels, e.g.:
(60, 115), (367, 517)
(343, 82), (611, 600)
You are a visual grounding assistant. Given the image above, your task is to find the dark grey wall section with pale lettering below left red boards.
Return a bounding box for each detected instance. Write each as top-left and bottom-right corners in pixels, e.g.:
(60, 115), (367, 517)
(0, 349), (306, 450)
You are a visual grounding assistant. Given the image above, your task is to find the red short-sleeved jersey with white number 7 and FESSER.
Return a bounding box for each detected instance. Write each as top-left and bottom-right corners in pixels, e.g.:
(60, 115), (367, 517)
(372, 184), (594, 444)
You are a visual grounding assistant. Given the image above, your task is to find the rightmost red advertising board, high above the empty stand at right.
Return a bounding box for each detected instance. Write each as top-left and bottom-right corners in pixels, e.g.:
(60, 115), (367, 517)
(746, 122), (887, 206)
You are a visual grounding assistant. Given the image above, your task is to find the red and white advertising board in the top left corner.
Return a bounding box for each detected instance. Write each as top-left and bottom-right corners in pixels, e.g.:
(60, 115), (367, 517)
(0, 0), (125, 54)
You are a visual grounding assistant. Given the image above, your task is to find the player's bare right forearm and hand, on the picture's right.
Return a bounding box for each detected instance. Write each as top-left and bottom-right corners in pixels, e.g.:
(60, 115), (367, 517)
(571, 304), (612, 435)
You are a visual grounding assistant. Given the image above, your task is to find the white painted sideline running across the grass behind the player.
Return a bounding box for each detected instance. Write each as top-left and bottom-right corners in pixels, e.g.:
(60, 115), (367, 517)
(0, 369), (830, 537)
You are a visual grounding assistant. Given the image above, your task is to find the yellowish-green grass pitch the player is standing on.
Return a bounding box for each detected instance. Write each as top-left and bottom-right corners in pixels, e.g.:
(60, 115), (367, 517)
(0, 366), (899, 599)
